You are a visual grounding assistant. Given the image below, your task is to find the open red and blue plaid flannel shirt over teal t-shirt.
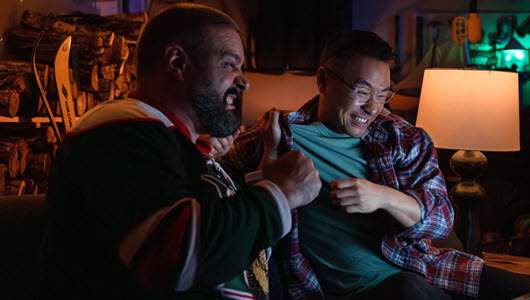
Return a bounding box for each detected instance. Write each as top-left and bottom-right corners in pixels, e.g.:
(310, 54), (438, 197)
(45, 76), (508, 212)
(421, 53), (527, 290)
(221, 96), (484, 299)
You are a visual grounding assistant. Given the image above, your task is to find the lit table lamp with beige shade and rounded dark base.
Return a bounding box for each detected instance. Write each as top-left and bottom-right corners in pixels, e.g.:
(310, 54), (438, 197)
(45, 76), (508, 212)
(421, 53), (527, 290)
(416, 69), (520, 255)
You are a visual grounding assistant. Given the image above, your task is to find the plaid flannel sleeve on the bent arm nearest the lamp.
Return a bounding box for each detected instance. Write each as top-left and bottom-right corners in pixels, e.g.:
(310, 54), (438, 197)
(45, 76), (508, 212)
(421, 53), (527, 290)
(395, 123), (454, 240)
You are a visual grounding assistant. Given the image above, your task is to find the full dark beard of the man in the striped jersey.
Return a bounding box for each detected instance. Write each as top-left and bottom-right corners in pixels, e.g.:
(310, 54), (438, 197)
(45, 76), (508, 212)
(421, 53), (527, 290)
(191, 79), (241, 137)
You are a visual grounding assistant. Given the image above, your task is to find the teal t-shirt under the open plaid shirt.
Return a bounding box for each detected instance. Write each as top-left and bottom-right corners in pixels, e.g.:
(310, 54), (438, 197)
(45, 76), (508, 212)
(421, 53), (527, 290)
(292, 122), (400, 296)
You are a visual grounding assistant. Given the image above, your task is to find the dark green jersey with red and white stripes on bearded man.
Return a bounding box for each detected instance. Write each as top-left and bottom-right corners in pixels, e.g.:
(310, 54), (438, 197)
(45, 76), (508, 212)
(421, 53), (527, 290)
(41, 94), (291, 299)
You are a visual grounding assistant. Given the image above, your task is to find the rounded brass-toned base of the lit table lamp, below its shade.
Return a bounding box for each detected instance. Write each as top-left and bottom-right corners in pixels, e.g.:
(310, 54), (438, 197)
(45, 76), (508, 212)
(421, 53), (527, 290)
(449, 150), (488, 256)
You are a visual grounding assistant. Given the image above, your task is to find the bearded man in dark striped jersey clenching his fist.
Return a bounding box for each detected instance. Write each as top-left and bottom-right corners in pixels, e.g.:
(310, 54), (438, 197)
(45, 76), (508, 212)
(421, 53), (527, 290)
(41, 4), (321, 299)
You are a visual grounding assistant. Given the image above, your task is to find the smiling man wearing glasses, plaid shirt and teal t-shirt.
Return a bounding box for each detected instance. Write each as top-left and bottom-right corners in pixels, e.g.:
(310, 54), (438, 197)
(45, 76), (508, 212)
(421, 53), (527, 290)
(216, 30), (524, 299)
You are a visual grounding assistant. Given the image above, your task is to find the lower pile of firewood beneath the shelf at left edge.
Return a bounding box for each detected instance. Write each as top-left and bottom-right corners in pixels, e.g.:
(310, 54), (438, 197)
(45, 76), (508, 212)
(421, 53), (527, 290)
(0, 132), (54, 195)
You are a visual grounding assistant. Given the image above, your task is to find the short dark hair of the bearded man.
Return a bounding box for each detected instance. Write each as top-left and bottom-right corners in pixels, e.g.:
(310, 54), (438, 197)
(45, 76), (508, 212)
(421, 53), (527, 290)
(136, 3), (241, 76)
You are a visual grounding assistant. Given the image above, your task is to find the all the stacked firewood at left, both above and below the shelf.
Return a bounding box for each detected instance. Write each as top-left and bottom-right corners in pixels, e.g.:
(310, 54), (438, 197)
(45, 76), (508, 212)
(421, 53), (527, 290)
(0, 11), (147, 195)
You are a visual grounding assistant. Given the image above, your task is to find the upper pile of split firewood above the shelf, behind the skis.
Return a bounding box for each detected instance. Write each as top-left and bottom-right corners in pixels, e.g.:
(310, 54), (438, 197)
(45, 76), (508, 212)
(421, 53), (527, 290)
(0, 11), (147, 116)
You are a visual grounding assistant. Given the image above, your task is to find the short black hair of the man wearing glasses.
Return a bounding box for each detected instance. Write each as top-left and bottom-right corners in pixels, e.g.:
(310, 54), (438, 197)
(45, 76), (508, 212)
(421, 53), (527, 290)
(320, 30), (395, 66)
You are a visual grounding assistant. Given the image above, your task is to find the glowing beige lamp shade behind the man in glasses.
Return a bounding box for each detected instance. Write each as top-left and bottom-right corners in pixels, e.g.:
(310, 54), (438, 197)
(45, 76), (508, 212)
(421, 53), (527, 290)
(416, 69), (520, 151)
